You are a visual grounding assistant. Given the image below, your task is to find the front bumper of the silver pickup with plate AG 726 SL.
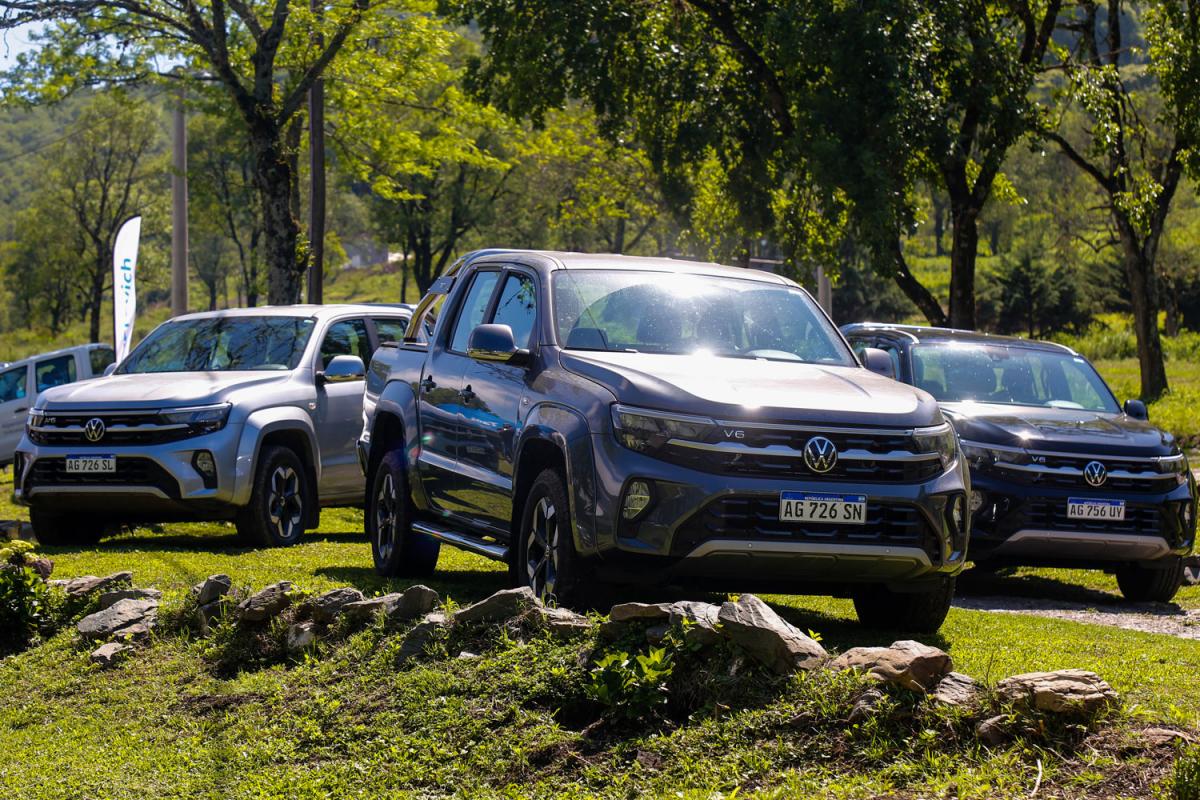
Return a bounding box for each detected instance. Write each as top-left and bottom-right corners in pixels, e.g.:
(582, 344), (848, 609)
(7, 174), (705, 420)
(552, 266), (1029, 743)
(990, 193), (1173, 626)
(13, 423), (245, 522)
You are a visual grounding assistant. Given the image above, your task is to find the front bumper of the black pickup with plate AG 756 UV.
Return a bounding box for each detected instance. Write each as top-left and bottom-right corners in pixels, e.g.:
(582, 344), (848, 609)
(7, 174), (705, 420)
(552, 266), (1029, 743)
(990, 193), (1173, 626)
(971, 470), (1195, 569)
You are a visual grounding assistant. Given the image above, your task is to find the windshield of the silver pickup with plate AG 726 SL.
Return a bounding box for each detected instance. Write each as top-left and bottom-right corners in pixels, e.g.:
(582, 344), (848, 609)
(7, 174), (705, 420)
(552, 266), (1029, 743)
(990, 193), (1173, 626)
(118, 317), (313, 374)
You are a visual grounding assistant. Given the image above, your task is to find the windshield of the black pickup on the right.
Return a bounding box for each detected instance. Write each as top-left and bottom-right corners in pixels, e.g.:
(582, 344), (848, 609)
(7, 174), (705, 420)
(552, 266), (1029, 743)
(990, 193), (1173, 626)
(912, 342), (1121, 414)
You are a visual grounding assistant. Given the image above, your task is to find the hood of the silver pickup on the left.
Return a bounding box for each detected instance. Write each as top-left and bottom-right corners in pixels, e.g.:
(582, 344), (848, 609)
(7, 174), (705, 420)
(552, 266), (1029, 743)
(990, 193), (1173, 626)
(37, 372), (293, 411)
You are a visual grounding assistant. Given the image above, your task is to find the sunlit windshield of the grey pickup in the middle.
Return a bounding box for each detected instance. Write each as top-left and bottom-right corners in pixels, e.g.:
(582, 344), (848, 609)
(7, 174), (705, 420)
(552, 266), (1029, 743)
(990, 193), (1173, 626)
(553, 270), (857, 367)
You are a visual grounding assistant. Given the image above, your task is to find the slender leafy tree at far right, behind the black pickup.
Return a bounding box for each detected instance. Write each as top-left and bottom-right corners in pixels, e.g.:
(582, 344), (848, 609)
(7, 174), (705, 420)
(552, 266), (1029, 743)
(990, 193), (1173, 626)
(1043, 0), (1200, 399)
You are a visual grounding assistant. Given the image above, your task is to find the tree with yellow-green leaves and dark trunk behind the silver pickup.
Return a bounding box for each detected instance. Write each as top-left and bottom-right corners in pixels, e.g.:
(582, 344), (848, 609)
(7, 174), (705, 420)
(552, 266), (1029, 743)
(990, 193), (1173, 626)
(0, 0), (427, 303)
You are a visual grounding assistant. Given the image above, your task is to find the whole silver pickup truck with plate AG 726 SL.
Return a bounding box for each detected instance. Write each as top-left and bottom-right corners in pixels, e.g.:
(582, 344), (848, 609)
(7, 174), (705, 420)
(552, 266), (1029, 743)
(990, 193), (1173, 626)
(13, 305), (412, 546)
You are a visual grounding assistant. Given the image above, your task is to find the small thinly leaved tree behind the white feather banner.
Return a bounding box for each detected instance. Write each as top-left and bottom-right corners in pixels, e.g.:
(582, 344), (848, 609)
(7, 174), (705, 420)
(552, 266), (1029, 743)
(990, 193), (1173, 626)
(43, 92), (162, 342)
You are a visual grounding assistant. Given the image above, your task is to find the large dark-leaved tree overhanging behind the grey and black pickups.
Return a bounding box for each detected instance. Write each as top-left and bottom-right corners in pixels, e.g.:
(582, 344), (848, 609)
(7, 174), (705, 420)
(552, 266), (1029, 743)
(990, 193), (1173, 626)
(455, 0), (1061, 326)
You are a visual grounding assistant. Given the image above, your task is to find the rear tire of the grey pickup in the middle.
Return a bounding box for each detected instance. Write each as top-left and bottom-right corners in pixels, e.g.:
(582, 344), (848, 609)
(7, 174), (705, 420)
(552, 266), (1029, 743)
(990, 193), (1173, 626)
(365, 450), (442, 578)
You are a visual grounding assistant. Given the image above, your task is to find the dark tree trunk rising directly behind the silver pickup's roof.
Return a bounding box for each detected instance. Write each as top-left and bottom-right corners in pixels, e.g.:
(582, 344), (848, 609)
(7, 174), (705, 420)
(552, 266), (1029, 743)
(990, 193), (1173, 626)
(246, 122), (305, 306)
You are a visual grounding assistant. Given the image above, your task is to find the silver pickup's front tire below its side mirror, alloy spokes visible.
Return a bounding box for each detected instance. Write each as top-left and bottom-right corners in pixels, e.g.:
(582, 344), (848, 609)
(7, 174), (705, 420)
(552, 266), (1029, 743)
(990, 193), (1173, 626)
(236, 445), (317, 547)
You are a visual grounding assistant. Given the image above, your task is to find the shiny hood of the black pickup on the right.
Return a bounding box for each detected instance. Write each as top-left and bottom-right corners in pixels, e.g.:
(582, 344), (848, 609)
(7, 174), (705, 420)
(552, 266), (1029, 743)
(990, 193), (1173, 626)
(942, 403), (1176, 456)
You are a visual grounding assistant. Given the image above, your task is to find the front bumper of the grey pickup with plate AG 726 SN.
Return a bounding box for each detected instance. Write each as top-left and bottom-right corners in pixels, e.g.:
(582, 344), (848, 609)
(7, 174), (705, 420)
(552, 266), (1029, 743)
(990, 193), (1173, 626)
(593, 434), (970, 590)
